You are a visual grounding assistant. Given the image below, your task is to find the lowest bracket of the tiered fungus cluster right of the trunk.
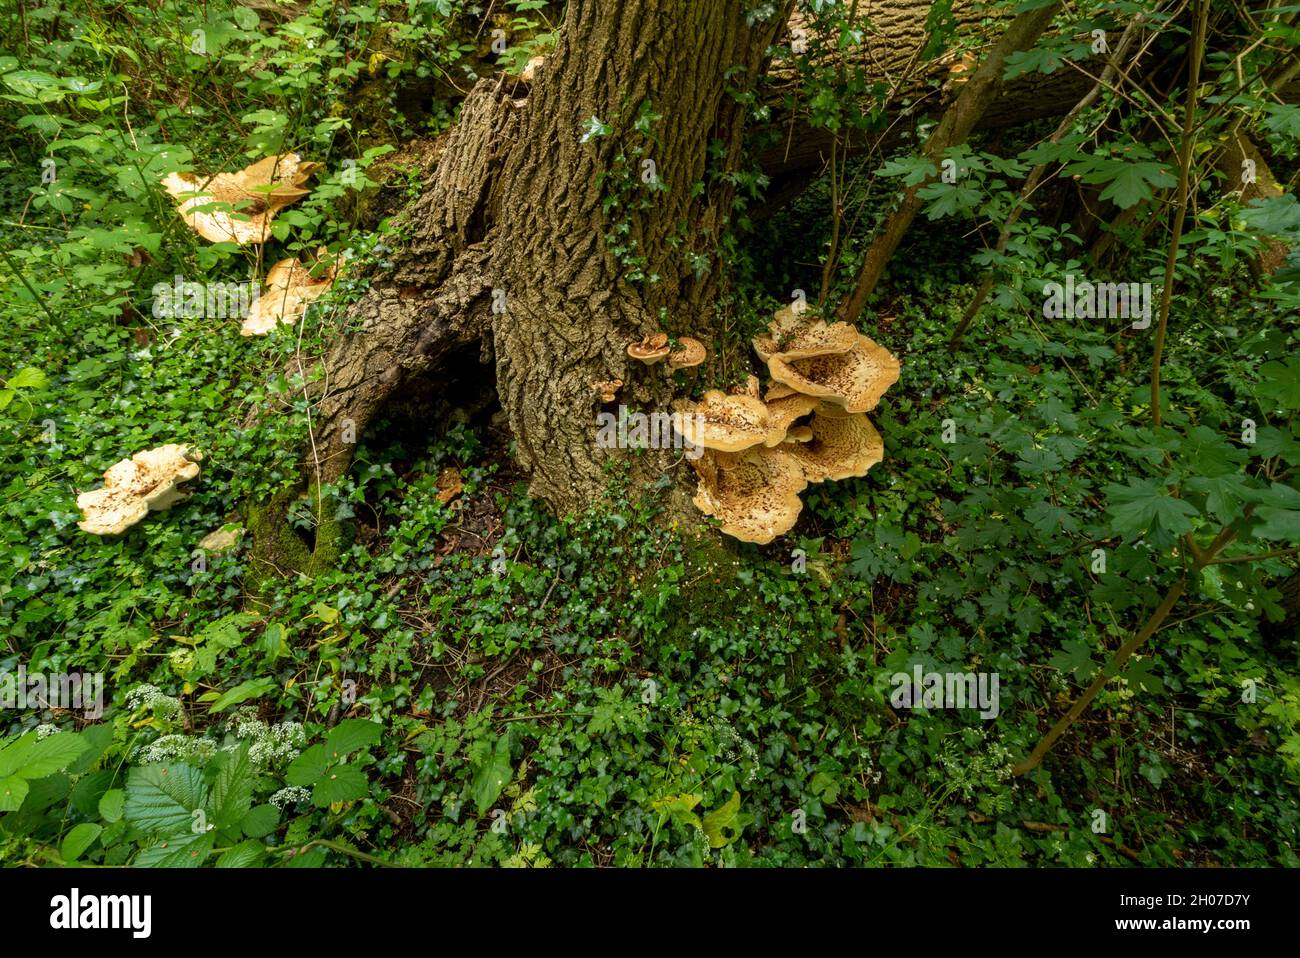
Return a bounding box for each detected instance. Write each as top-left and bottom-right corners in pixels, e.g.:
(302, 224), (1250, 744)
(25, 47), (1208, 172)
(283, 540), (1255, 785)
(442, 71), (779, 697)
(690, 446), (807, 546)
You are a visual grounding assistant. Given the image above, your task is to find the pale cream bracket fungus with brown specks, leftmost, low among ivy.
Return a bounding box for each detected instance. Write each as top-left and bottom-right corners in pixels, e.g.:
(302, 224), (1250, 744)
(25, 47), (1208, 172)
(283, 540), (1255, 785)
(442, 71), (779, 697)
(77, 443), (202, 536)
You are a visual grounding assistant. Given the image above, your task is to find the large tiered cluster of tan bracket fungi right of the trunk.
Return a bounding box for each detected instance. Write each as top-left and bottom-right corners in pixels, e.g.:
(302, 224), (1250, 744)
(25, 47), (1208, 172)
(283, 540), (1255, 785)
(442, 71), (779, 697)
(679, 309), (900, 545)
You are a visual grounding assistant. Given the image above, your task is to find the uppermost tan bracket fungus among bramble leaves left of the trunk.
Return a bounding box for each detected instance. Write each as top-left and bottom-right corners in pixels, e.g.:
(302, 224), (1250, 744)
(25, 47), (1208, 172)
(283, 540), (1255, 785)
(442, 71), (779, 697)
(163, 153), (320, 246)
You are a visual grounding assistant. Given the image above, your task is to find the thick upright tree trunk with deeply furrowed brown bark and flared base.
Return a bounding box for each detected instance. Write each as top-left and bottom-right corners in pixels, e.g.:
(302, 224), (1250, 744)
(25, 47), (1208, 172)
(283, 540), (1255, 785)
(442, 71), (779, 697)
(308, 0), (793, 511)
